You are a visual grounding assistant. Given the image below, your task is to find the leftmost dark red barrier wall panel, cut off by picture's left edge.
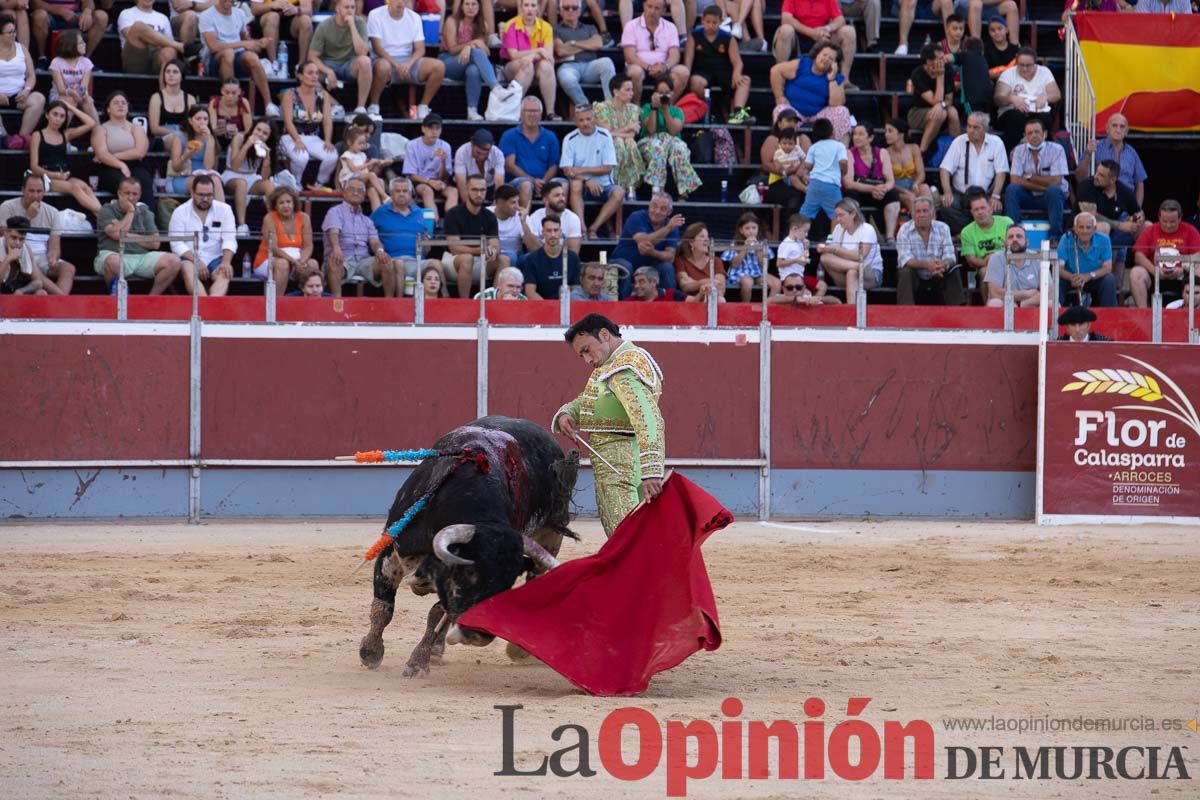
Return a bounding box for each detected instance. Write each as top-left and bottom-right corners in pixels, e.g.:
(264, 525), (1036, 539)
(0, 335), (188, 461)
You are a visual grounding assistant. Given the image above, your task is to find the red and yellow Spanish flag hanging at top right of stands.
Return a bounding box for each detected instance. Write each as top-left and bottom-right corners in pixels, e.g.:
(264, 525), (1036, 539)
(1075, 11), (1200, 131)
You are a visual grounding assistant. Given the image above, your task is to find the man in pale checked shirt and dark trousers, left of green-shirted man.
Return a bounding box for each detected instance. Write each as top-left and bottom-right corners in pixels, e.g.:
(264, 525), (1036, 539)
(896, 197), (964, 306)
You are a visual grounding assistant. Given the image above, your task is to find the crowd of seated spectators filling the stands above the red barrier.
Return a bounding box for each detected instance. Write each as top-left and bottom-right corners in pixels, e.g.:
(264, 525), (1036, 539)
(0, 0), (1200, 306)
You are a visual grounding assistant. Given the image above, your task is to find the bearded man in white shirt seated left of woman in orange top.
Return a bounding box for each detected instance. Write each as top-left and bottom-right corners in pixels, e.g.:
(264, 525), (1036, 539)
(168, 175), (238, 297)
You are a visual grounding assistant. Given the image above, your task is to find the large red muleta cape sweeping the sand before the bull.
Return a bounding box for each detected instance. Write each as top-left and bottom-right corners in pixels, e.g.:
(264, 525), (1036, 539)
(458, 473), (733, 696)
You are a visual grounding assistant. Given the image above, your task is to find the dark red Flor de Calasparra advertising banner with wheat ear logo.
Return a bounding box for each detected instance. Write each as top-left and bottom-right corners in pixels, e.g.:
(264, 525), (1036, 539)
(1039, 342), (1200, 524)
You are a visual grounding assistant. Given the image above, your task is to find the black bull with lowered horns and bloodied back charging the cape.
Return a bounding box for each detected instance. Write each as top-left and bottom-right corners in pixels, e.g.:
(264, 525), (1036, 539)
(359, 416), (580, 676)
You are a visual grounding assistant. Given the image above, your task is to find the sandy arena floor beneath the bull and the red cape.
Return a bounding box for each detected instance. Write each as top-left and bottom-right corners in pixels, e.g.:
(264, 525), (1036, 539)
(0, 521), (1200, 800)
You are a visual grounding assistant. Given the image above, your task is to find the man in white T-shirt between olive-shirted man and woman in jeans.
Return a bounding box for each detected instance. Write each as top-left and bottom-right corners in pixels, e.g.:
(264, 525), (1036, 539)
(367, 0), (446, 120)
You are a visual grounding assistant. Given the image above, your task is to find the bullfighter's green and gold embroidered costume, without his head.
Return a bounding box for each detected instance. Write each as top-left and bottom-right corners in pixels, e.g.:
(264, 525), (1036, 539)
(553, 342), (666, 536)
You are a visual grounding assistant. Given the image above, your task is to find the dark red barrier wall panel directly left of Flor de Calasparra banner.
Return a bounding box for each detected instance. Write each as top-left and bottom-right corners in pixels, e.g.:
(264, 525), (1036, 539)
(770, 342), (1038, 470)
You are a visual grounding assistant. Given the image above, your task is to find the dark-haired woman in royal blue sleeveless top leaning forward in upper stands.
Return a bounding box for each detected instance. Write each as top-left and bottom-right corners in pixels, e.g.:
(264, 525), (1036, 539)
(770, 42), (851, 144)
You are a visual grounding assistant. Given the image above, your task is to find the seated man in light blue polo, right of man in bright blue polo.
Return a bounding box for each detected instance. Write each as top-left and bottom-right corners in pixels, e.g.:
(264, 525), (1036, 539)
(558, 101), (625, 239)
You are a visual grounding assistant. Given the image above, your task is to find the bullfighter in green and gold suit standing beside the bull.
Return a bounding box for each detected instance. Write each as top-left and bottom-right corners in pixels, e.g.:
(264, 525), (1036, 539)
(550, 314), (666, 536)
